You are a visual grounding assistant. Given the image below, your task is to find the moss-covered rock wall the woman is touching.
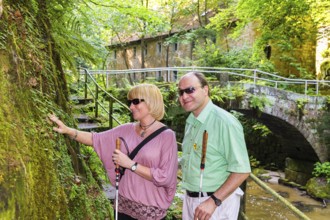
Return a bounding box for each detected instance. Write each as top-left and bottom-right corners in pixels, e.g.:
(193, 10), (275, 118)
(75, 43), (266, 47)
(0, 1), (111, 220)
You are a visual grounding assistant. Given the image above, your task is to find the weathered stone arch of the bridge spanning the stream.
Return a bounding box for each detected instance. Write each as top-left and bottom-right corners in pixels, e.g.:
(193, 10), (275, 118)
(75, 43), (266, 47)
(229, 84), (328, 162)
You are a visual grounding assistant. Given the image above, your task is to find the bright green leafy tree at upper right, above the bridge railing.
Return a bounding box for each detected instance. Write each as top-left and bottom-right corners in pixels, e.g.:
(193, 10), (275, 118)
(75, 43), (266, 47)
(236, 0), (316, 78)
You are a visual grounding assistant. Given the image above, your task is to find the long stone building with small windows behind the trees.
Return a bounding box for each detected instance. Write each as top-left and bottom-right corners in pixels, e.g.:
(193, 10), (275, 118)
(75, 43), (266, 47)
(107, 12), (255, 81)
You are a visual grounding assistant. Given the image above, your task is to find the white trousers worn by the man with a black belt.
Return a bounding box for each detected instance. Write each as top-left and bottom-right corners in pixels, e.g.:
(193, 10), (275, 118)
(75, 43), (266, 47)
(182, 188), (244, 220)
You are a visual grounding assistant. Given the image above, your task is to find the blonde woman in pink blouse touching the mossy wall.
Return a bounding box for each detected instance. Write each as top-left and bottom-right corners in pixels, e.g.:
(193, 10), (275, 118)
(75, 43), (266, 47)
(50, 84), (178, 220)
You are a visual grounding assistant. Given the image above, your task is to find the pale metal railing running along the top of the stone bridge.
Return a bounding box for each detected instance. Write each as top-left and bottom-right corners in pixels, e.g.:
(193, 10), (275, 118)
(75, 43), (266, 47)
(82, 67), (330, 95)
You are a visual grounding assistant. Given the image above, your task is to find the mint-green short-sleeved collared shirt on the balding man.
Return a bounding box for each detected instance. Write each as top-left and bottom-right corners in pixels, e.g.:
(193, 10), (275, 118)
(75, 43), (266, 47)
(181, 101), (251, 192)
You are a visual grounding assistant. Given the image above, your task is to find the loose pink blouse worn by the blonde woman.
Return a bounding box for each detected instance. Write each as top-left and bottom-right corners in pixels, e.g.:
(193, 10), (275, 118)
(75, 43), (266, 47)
(93, 123), (178, 209)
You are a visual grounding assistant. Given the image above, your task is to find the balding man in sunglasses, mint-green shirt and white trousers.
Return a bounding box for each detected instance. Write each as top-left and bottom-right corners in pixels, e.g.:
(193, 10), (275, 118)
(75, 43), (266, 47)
(178, 72), (251, 220)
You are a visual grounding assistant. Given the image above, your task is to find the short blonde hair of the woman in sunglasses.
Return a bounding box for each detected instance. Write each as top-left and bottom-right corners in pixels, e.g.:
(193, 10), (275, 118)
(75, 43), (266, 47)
(127, 84), (165, 121)
